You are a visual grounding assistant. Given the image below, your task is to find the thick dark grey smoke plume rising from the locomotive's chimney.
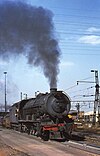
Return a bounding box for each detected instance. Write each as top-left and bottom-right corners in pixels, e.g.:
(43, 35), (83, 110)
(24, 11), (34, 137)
(0, 0), (60, 87)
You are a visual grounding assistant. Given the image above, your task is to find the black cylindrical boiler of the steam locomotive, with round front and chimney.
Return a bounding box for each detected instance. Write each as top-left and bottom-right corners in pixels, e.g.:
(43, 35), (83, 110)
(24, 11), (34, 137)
(23, 89), (71, 119)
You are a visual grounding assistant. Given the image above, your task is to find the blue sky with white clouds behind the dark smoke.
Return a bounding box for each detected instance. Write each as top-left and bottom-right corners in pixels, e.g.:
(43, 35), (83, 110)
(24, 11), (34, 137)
(0, 0), (100, 111)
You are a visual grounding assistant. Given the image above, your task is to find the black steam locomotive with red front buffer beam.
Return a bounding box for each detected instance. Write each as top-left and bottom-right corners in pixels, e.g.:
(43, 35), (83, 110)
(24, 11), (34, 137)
(2, 88), (74, 141)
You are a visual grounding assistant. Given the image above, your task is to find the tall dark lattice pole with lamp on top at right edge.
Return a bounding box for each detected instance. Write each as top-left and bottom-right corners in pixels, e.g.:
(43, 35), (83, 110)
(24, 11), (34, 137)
(91, 70), (100, 125)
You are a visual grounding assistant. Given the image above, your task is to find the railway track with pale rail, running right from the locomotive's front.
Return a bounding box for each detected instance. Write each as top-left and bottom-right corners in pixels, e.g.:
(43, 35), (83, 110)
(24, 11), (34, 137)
(50, 132), (100, 155)
